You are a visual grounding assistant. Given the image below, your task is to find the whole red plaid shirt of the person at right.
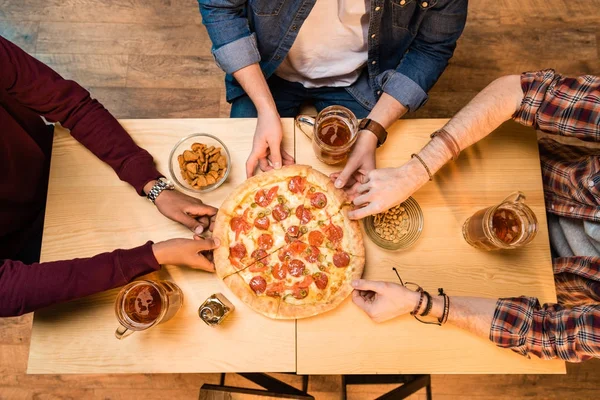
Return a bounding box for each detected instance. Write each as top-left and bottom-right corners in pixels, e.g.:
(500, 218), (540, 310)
(490, 70), (600, 362)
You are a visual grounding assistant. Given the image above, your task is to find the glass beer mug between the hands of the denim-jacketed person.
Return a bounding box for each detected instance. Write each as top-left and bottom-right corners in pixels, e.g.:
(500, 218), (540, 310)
(296, 106), (358, 165)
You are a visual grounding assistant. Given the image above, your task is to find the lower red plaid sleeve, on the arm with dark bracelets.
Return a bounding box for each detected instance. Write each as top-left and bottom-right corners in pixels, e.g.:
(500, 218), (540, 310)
(490, 297), (600, 362)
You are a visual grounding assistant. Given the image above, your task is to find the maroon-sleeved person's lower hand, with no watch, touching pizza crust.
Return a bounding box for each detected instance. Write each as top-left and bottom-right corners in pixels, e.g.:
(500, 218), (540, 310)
(152, 236), (221, 272)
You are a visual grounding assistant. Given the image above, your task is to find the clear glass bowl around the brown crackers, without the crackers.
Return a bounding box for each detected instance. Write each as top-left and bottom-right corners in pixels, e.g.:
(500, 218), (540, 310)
(169, 133), (231, 193)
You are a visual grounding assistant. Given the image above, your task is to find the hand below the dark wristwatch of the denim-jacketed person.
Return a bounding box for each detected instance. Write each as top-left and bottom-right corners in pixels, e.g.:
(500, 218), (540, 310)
(330, 131), (377, 189)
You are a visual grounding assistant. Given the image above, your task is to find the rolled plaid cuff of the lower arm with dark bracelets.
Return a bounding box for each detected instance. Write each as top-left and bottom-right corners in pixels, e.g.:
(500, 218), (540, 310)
(490, 296), (539, 355)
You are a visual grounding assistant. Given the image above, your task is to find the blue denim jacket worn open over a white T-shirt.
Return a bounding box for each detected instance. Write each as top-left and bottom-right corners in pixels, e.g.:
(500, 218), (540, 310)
(198, 0), (468, 111)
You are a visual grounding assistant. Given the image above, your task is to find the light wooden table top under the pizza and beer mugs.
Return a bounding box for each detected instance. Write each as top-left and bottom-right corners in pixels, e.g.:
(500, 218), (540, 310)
(28, 119), (565, 374)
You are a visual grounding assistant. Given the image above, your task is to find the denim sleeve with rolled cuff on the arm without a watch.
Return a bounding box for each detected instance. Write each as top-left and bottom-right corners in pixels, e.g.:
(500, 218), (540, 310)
(198, 0), (260, 74)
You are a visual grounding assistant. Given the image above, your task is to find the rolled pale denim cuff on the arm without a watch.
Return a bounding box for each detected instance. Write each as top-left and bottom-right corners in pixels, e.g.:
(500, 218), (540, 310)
(213, 33), (260, 74)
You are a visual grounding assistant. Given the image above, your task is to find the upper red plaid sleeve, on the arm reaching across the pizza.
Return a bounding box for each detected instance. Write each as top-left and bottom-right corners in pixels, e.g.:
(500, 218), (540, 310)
(513, 69), (600, 141)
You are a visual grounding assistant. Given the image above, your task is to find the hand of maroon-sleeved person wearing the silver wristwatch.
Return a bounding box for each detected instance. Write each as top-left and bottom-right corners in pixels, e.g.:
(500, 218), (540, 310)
(146, 186), (218, 235)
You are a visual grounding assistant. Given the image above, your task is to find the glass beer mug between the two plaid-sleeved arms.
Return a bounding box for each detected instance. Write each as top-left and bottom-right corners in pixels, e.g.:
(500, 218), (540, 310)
(463, 192), (538, 250)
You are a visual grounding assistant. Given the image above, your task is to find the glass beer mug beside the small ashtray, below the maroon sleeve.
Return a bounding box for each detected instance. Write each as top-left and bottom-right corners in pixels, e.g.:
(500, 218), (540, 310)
(115, 281), (183, 339)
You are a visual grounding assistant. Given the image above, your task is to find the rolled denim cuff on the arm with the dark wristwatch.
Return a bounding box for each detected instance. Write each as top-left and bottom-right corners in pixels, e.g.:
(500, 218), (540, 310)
(377, 70), (427, 111)
